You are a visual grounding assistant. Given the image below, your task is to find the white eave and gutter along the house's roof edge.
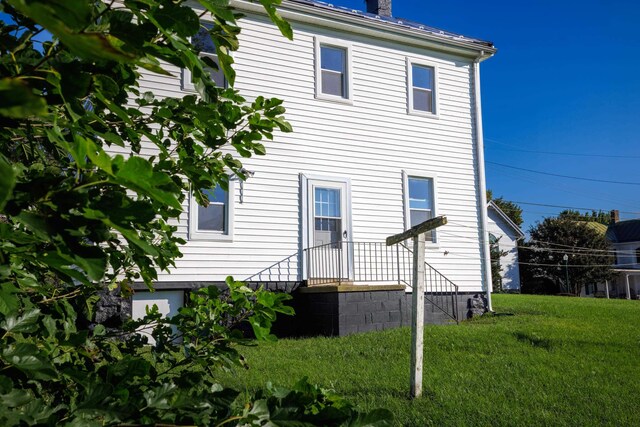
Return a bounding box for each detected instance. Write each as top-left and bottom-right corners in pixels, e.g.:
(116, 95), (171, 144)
(230, 0), (497, 61)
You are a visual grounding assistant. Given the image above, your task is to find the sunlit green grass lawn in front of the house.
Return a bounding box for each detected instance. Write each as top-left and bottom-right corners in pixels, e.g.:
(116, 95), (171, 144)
(223, 295), (640, 426)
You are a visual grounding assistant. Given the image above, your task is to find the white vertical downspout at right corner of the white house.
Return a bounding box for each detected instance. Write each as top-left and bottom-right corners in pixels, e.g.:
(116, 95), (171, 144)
(473, 51), (493, 312)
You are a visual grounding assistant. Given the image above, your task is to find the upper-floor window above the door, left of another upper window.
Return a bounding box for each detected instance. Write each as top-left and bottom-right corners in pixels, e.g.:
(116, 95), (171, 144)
(316, 37), (352, 102)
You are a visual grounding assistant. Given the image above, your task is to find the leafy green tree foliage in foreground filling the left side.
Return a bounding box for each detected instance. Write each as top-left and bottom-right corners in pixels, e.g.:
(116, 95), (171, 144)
(0, 0), (390, 426)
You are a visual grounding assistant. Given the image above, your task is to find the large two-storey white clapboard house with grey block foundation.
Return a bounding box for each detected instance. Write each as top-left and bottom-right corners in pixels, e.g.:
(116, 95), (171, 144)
(127, 0), (496, 335)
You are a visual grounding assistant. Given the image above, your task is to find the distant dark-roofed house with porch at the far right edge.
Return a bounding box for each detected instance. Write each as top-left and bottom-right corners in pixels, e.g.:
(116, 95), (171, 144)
(607, 211), (640, 299)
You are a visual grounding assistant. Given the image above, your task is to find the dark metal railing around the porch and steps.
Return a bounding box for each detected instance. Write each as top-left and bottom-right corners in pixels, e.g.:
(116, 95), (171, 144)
(245, 241), (460, 322)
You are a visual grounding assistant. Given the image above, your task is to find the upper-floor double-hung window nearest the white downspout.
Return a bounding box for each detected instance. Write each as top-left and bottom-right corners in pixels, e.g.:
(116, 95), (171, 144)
(407, 60), (437, 116)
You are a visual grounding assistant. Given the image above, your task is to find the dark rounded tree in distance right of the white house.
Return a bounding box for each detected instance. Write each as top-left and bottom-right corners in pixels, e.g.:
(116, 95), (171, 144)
(519, 217), (614, 295)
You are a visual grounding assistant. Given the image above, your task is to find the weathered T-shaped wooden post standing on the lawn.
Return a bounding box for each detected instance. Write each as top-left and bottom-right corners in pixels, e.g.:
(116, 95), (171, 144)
(387, 216), (447, 398)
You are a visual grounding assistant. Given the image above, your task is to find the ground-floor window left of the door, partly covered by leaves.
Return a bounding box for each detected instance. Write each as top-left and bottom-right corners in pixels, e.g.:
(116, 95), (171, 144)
(189, 180), (235, 240)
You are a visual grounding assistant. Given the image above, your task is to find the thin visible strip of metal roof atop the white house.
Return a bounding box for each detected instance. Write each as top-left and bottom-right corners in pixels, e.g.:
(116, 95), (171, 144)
(289, 0), (494, 50)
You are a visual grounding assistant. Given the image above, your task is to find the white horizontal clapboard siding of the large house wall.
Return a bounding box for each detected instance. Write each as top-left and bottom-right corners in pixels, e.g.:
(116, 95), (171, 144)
(122, 10), (482, 291)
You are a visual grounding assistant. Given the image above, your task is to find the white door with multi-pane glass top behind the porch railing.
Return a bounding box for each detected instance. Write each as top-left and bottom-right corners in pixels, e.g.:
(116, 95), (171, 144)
(303, 178), (353, 284)
